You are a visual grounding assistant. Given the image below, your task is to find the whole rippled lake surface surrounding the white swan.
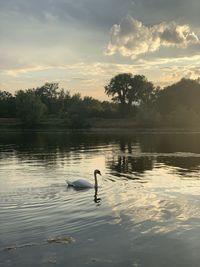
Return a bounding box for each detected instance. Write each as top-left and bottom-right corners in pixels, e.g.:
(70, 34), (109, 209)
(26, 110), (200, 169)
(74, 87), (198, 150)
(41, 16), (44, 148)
(0, 132), (200, 267)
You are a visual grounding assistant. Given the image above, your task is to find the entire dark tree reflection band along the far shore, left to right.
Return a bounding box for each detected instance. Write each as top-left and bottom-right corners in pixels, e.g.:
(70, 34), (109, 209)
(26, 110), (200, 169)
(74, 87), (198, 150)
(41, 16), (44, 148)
(0, 131), (200, 178)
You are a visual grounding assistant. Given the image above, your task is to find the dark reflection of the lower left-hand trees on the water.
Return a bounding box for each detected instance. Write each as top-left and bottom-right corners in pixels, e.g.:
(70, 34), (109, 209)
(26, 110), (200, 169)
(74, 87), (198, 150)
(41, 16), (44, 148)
(0, 132), (110, 167)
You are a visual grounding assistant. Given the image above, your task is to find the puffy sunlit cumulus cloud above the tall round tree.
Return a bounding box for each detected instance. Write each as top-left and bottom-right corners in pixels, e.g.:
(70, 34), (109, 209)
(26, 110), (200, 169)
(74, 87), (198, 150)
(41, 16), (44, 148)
(106, 16), (200, 58)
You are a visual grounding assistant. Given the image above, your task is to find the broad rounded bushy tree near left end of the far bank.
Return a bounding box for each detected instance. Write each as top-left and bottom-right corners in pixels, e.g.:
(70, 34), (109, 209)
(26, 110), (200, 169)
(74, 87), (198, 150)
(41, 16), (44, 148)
(16, 89), (46, 126)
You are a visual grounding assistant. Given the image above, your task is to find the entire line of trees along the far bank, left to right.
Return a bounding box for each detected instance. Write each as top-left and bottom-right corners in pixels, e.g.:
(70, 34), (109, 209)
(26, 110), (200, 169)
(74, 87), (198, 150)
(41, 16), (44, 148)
(0, 73), (200, 128)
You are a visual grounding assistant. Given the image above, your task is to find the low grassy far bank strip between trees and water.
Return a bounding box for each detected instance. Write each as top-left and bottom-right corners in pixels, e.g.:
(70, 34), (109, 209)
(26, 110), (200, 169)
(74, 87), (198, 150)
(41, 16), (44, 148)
(0, 118), (200, 133)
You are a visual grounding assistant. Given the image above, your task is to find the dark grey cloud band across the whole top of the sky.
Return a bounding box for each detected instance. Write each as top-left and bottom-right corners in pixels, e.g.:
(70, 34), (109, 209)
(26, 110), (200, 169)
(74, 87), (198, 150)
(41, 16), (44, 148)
(0, 0), (200, 29)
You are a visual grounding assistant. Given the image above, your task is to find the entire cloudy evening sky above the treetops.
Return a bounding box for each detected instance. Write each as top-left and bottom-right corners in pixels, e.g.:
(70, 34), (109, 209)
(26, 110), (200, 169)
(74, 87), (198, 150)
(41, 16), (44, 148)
(0, 0), (200, 100)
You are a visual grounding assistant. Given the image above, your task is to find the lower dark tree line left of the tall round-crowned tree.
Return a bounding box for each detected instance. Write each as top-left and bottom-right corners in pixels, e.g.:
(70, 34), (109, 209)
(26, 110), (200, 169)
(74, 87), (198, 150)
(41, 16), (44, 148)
(0, 83), (117, 128)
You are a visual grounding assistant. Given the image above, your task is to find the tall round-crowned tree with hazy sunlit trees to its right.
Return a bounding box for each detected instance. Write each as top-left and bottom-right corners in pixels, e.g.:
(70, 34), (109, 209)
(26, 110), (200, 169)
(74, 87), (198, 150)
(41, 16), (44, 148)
(105, 73), (200, 127)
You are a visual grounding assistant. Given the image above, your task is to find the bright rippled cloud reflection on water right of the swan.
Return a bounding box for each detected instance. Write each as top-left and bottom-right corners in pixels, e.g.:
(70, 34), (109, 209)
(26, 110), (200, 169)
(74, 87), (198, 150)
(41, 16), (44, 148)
(106, 183), (200, 234)
